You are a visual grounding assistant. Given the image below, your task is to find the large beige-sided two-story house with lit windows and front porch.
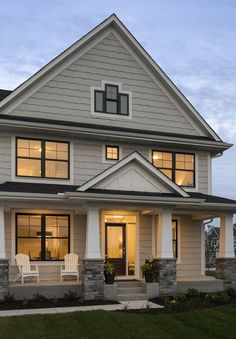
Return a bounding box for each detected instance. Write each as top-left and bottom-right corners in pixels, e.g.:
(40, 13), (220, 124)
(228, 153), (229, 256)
(0, 15), (236, 299)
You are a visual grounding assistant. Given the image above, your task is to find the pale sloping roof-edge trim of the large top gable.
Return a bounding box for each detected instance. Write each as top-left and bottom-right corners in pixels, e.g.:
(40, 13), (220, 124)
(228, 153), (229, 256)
(0, 14), (221, 141)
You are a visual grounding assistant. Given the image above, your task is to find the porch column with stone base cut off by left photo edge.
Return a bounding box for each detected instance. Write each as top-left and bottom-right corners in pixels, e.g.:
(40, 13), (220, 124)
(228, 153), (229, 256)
(0, 206), (8, 299)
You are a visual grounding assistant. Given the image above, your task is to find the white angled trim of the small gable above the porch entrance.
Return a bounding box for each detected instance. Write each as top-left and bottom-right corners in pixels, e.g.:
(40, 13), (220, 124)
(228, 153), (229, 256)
(77, 152), (189, 197)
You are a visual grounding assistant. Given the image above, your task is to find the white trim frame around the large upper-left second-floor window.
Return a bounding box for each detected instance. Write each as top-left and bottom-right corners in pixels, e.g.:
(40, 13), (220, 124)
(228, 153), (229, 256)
(11, 134), (74, 185)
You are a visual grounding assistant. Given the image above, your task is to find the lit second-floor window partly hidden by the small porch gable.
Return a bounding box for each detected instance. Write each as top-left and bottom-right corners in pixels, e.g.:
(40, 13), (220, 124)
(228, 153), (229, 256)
(152, 151), (195, 187)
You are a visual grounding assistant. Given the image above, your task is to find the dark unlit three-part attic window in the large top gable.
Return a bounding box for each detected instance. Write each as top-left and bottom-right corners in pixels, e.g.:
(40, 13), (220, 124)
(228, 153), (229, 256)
(95, 84), (129, 115)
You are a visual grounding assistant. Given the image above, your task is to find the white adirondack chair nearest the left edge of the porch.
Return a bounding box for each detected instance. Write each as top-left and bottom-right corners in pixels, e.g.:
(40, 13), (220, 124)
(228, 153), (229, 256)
(15, 254), (39, 284)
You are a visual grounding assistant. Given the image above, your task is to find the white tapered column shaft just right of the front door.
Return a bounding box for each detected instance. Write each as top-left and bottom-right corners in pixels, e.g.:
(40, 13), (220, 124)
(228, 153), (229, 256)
(156, 209), (174, 259)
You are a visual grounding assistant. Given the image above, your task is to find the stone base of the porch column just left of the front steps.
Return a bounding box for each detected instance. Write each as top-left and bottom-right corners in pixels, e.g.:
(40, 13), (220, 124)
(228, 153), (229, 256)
(82, 259), (104, 300)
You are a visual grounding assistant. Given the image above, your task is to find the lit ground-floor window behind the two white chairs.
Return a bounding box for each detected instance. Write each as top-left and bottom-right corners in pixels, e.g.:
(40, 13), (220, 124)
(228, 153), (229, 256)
(16, 214), (70, 261)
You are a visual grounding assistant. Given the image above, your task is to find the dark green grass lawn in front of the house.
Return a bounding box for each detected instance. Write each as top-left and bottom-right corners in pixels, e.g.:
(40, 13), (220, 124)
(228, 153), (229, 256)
(0, 306), (236, 339)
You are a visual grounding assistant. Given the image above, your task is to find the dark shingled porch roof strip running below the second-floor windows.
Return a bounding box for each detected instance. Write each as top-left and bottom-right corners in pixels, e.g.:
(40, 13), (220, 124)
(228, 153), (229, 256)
(0, 181), (236, 205)
